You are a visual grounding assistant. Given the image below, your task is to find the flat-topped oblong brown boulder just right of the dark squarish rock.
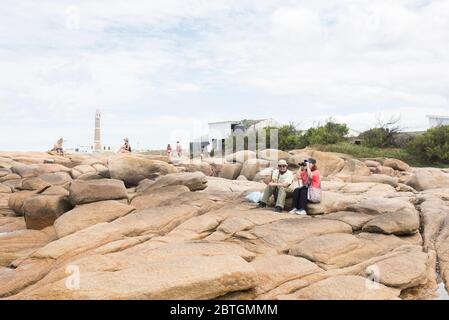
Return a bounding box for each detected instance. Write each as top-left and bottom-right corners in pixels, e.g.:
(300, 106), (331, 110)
(69, 179), (128, 205)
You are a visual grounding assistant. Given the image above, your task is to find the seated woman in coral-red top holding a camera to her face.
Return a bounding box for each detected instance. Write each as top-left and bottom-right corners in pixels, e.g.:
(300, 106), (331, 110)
(290, 158), (321, 215)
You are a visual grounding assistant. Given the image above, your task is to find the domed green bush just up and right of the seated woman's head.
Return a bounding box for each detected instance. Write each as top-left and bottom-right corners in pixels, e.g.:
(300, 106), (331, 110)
(305, 120), (349, 145)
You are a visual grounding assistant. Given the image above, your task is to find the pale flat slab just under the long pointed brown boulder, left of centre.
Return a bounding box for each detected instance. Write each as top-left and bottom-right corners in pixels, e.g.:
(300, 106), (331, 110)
(131, 185), (190, 210)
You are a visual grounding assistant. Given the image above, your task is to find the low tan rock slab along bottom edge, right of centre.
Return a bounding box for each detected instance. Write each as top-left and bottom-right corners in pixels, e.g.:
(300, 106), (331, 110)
(294, 276), (400, 300)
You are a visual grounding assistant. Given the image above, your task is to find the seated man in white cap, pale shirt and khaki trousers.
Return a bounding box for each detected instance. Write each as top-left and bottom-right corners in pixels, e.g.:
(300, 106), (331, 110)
(258, 160), (293, 212)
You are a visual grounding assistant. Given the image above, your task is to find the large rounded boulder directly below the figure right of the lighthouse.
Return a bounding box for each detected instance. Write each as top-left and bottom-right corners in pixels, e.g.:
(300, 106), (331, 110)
(108, 156), (177, 186)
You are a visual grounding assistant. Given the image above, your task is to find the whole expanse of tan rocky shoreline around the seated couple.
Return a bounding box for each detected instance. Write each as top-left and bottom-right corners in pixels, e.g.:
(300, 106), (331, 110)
(0, 149), (449, 300)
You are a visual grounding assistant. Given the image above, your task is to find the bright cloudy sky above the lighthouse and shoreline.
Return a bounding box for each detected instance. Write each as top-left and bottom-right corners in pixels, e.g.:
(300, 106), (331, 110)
(0, 0), (449, 150)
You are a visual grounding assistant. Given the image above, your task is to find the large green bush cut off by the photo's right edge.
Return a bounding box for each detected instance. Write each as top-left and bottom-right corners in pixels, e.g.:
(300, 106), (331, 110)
(407, 125), (449, 163)
